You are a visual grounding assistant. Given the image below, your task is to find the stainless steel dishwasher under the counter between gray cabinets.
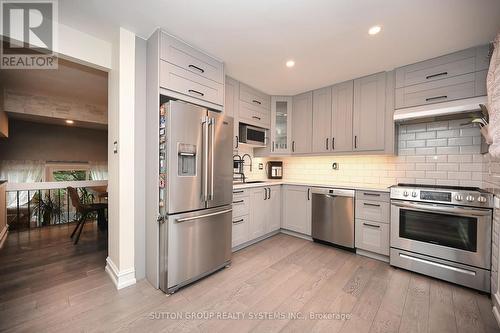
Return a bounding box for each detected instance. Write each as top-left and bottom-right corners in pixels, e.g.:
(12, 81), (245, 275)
(312, 188), (354, 249)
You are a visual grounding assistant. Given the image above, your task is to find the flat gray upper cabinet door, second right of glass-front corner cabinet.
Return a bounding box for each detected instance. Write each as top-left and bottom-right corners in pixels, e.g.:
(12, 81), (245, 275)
(312, 87), (332, 153)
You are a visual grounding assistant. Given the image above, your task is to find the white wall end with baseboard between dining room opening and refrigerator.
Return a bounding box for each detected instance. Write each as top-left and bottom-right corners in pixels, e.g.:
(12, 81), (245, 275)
(106, 28), (136, 289)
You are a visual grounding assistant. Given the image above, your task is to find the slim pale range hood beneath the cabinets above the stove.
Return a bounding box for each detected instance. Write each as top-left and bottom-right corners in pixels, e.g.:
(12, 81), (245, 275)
(394, 96), (487, 123)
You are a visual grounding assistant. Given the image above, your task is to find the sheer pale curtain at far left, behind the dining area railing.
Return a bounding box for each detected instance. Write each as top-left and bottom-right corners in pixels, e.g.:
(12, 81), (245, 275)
(0, 161), (45, 208)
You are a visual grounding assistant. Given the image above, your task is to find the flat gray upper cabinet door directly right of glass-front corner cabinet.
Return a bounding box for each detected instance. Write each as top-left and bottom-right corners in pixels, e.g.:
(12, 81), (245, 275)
(292, 92), (313, 154)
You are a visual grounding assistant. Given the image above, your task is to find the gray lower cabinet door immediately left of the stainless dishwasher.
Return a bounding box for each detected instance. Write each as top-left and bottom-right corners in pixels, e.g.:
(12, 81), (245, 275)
(283, 185), (311, 236)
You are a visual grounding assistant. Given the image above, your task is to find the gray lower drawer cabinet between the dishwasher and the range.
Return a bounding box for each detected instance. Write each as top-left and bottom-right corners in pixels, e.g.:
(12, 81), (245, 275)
(354, 191), (390, 256)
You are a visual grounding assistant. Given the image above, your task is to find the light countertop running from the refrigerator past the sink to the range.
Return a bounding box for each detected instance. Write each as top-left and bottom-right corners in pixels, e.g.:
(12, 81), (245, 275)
(233, 180), (390, 192)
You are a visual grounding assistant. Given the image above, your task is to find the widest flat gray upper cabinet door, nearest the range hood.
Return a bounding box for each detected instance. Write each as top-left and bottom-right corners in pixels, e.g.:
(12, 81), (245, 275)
(353, 72), (386, 151)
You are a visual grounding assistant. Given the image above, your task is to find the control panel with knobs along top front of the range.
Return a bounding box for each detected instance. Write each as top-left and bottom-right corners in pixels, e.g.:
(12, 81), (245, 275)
(391, 186), (493, 208)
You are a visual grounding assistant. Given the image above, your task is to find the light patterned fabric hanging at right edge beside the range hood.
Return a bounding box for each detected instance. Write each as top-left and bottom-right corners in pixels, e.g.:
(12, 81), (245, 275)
(486, 33), (500, 159)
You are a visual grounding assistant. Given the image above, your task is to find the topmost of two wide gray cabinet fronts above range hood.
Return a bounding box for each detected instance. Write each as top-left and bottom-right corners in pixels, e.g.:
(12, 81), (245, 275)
(396, 45), (489, 88)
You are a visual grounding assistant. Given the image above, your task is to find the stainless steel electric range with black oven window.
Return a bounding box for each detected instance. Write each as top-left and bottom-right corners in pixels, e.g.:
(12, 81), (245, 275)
(390, 184), (494, 292)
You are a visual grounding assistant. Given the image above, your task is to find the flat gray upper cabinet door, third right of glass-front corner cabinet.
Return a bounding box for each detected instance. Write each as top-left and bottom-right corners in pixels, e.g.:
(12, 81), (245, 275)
(330, 80), (353, 153)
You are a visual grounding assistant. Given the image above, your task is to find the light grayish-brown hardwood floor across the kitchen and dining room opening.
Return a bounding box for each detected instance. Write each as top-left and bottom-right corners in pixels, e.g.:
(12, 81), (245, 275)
(0, 234), (500, 332)
